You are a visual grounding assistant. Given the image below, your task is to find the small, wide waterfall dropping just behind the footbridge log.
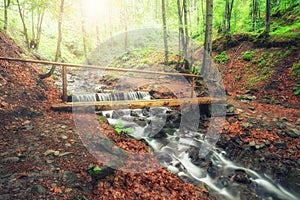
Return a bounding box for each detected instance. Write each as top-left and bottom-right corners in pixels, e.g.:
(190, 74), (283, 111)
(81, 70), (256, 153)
(72, 92), (151, 102)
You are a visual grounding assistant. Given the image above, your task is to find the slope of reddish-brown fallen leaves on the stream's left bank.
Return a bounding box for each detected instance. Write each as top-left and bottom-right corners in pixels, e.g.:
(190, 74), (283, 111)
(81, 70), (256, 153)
(0, 29), (207, 200)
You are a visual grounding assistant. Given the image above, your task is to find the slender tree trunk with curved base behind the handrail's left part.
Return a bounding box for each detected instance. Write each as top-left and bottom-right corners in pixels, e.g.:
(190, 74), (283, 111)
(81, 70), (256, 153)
(40, 0), (64, 79)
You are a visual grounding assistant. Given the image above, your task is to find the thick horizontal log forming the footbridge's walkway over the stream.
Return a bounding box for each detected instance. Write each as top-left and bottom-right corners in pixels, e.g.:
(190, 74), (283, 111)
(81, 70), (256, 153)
(52, 97), (225, 112)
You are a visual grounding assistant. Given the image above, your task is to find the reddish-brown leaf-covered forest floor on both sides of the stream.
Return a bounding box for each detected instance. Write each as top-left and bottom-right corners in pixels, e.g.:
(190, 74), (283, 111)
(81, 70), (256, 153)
(0, 28), (300, 200)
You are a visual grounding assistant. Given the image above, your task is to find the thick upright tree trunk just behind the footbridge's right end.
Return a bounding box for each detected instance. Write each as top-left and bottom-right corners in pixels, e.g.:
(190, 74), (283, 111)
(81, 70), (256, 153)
(201, 0), (213, 77)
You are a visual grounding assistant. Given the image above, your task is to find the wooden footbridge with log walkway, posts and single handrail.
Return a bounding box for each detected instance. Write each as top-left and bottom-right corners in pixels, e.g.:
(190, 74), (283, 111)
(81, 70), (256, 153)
(0, 57), (225, 111)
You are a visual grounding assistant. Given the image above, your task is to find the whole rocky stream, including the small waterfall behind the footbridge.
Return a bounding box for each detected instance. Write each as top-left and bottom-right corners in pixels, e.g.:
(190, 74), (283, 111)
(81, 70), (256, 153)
(73, 92), (300, 200)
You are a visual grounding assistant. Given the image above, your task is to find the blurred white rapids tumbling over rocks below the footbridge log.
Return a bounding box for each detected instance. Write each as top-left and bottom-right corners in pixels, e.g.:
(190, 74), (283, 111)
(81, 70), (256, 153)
(103, 108), (299, 200)
